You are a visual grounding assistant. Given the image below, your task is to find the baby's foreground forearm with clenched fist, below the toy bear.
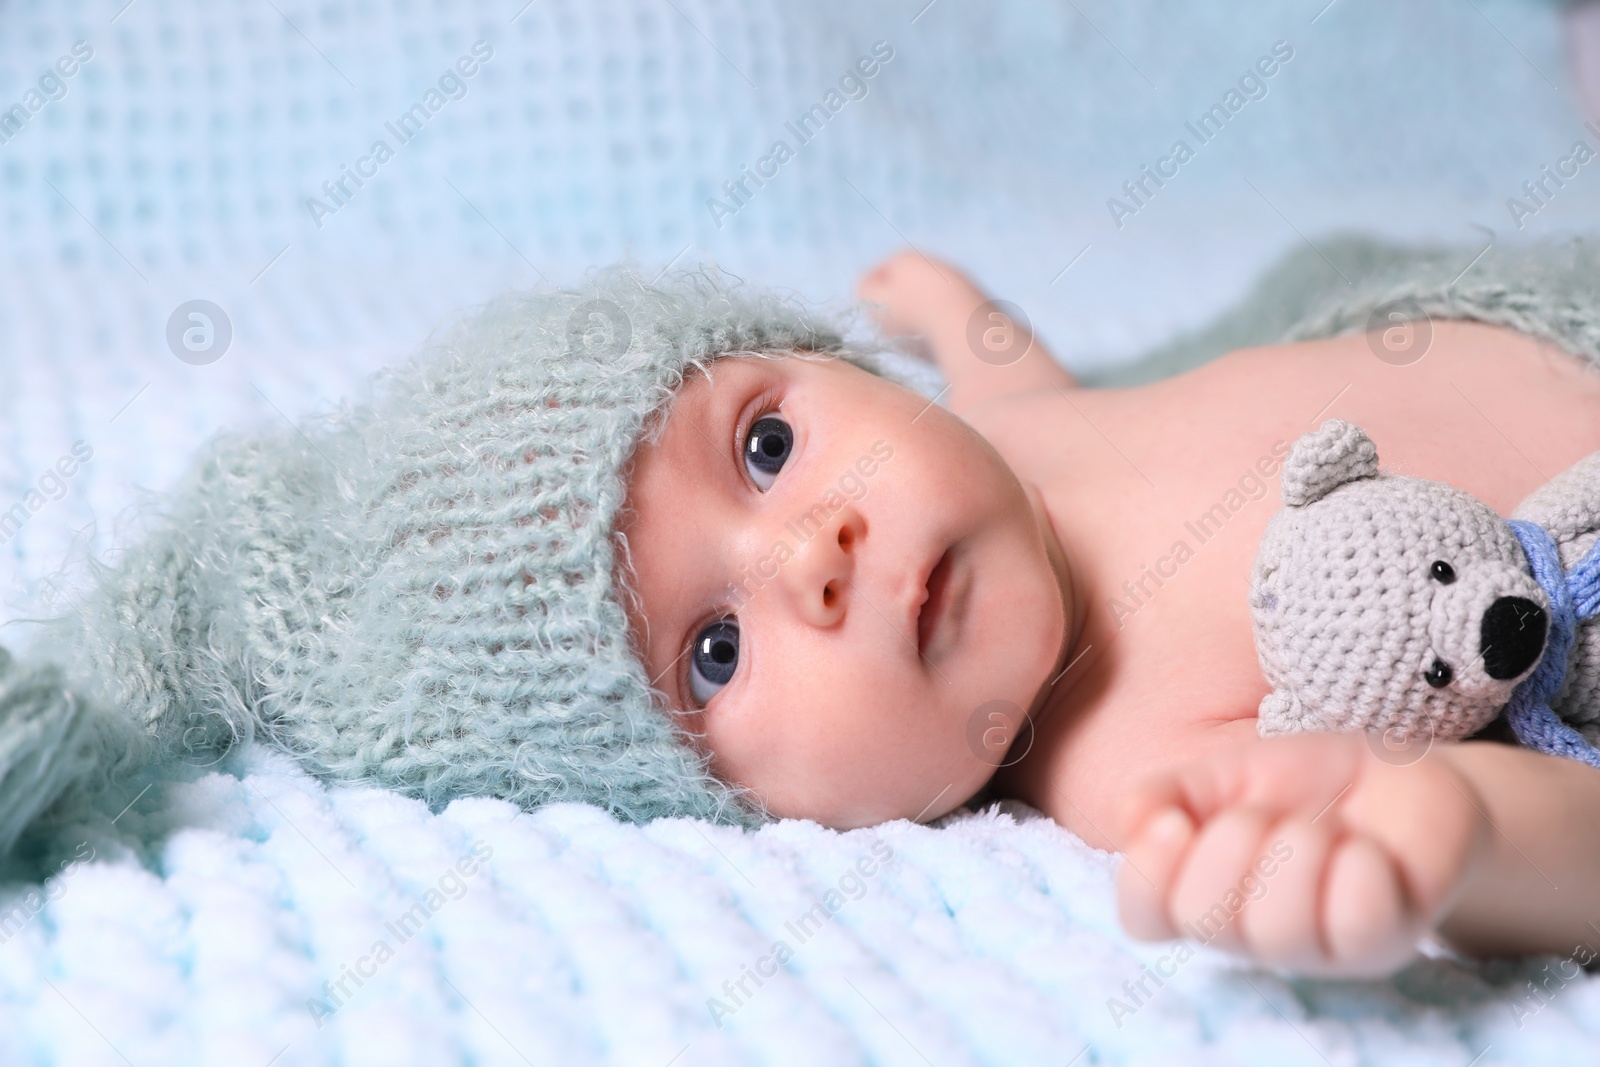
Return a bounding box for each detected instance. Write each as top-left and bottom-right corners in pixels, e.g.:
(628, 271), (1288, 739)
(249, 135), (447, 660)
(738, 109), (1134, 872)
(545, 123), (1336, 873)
(1118, 734), (1600, 976)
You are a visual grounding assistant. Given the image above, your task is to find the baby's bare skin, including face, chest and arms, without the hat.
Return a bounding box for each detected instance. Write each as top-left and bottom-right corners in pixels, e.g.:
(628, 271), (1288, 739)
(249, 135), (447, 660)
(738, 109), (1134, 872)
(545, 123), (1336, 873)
(621, 254), (1600, 974)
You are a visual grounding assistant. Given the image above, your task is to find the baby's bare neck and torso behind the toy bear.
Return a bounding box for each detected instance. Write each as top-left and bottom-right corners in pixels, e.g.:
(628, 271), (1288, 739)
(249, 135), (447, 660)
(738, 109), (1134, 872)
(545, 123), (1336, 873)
(979, 323), (1600, 832)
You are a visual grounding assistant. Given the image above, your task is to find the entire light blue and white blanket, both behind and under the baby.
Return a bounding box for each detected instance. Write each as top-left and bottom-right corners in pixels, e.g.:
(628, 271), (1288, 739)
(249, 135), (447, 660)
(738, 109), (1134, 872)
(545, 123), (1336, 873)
(0, 0), (1600, 1067)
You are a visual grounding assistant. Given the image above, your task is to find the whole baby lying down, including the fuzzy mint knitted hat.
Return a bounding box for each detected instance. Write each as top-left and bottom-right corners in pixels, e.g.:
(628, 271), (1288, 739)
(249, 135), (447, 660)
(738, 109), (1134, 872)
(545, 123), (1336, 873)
(12, 254), (1600, 974)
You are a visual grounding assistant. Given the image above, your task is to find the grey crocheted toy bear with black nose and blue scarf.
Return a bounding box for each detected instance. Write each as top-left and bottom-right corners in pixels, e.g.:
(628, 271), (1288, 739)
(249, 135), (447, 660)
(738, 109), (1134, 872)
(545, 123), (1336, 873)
(1250, 419), (1600, 766)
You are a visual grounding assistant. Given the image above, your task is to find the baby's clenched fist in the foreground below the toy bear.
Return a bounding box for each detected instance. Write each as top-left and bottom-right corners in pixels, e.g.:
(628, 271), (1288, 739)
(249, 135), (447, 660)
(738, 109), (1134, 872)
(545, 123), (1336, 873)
(1117, 734), (1488, 976)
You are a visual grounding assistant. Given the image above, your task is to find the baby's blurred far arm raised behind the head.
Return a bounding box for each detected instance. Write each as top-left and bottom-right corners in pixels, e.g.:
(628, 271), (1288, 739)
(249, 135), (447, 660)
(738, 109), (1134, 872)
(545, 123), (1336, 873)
(856, 251), (1077, 414)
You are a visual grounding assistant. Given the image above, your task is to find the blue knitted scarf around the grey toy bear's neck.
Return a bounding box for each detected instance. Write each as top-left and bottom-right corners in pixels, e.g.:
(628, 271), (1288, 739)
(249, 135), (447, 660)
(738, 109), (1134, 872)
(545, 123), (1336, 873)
(1504, 518), (1600, 768)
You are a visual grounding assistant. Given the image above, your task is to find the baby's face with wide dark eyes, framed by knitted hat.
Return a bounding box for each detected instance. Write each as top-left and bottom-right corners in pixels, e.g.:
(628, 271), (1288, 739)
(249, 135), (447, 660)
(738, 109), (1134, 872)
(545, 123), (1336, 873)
(621, 357), (1066, 829)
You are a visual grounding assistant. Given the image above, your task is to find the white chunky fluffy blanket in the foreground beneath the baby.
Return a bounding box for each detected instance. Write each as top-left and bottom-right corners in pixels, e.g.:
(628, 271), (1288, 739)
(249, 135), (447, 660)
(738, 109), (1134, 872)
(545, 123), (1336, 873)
(0, 750), (1600, 1067)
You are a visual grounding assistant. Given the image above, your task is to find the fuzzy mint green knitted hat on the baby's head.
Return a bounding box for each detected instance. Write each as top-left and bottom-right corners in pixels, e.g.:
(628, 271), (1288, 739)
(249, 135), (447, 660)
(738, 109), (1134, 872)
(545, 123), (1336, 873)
(31, 269), (938, 822)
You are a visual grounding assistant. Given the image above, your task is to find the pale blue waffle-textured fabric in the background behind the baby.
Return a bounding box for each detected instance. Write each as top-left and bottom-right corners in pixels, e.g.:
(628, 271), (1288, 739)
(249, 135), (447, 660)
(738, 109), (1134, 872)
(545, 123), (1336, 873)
(0, 0), (1600, 627)
